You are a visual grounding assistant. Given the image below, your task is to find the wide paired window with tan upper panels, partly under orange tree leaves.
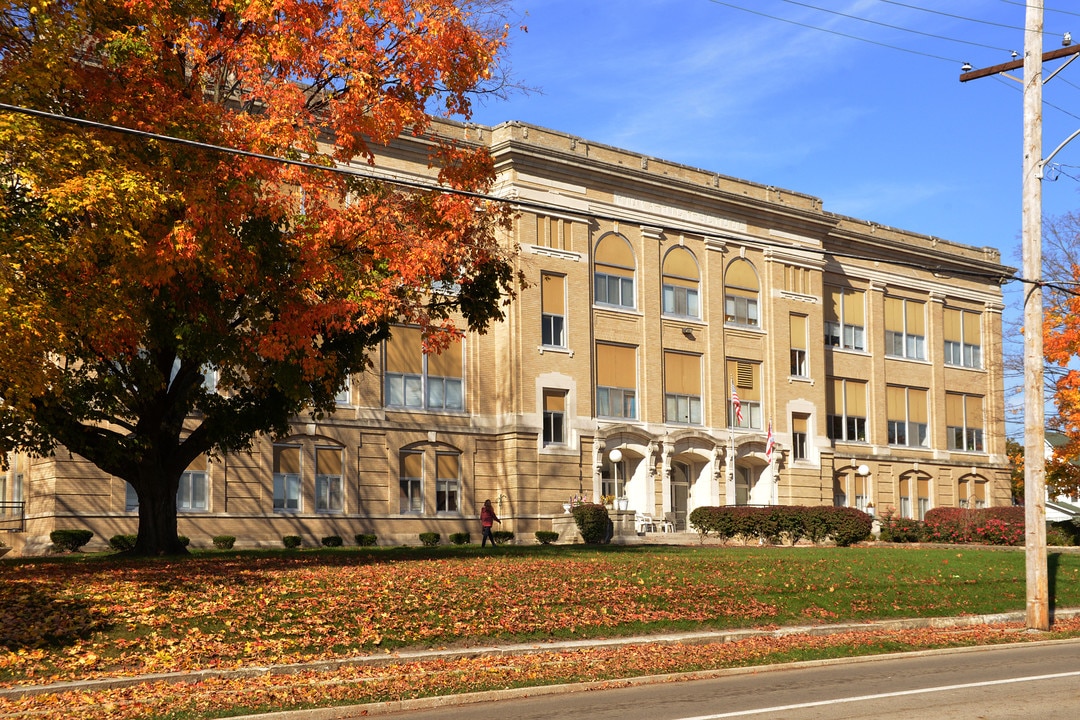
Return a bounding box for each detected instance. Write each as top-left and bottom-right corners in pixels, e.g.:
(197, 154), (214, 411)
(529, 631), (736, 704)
(386, 327), (464, 410)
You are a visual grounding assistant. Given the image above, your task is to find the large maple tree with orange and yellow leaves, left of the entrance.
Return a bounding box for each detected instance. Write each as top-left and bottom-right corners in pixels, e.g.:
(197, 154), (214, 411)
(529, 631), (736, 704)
(0, 0), (514, 554)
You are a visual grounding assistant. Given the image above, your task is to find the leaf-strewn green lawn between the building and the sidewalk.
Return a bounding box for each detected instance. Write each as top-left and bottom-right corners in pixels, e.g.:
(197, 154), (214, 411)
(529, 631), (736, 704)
(0, 546), (1080, 685)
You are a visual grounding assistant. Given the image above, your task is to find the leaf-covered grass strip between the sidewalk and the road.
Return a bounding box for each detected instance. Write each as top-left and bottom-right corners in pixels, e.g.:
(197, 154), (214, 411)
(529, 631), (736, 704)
(6, 619), (1080, 720)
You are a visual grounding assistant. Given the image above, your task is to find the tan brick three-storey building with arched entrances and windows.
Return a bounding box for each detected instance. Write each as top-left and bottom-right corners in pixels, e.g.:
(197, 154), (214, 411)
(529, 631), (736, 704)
(0, 122), (1012, 552)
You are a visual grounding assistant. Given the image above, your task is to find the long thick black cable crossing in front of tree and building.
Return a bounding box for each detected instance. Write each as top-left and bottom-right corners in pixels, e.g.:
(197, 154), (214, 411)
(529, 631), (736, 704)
(0, 103), (1036, 294)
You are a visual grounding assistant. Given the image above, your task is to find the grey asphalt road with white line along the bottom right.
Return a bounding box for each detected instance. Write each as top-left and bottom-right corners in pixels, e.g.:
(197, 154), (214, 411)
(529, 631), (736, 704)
(371, 640), (1080, 720)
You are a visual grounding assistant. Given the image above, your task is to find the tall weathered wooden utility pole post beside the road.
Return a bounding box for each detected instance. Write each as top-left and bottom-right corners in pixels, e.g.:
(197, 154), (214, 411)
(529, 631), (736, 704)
(1021, 0), (1050, 630)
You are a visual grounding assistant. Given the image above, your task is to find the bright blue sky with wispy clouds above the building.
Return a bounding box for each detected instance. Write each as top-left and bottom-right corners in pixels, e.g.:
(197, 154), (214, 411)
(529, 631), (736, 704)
(473, 0), (1080, 434)
